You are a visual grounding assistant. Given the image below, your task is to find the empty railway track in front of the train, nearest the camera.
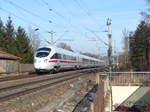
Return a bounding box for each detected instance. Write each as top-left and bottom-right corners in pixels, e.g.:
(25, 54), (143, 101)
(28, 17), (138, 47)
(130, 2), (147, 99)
(0, 68), (99, 102)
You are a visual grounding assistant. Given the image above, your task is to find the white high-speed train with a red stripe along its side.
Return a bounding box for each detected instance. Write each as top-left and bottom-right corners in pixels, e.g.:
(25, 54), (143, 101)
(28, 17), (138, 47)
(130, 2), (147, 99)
(34, 46), (104, 72)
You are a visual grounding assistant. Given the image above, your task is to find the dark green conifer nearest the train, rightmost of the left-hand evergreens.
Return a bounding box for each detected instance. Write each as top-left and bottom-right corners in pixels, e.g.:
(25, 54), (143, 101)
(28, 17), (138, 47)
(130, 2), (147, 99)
(16, 26), (33, 63)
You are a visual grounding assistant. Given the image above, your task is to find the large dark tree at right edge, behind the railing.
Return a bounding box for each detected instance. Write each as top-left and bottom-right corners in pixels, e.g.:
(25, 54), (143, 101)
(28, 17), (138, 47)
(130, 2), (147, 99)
(130, 21), (150, 70)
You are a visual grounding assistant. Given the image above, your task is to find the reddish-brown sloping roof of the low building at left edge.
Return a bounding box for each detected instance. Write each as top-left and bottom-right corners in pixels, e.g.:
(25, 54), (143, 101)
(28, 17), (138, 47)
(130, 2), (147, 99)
(0, 50), (21, 60)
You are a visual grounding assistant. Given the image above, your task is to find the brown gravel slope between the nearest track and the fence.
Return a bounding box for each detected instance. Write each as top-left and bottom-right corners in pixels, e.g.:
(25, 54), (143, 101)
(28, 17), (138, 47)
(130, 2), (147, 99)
(0, 75), (94, 112)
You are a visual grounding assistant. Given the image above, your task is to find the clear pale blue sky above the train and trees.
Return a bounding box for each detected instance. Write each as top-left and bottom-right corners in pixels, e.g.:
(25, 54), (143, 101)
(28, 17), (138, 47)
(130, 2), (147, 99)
(0, 0), (148, 54)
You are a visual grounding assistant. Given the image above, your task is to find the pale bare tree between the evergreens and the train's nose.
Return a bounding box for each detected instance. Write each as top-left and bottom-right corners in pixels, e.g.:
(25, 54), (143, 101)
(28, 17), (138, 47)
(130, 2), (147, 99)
(29, 27), (41, 51)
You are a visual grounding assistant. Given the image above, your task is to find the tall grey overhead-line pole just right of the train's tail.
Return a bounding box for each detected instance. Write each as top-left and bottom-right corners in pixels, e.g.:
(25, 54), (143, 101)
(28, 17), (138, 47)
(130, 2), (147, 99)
(106, 18), (112, 72)
